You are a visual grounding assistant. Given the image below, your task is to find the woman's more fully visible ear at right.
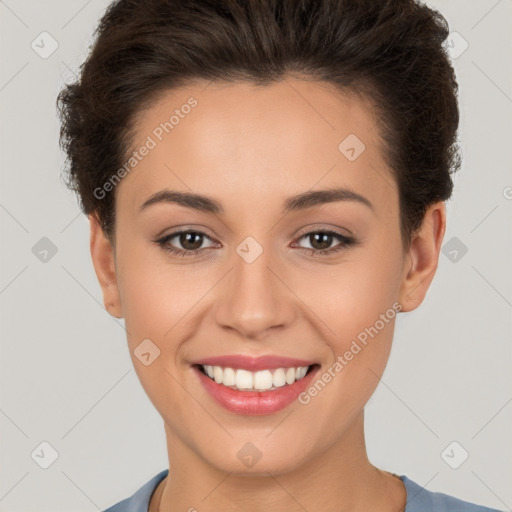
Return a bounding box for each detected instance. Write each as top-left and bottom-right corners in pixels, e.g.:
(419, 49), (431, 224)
(400, 201), (446, 312)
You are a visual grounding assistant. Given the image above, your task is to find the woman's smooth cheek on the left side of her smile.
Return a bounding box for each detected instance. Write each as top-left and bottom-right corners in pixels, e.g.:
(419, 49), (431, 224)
(115, 251), (195, 420)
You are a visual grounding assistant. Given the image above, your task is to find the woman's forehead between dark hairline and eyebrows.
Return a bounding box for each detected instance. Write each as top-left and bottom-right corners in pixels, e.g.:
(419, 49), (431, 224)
(118, 78), (396, 216)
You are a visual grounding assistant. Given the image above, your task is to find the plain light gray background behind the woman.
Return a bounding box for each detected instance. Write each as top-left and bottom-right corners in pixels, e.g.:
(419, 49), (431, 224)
(0, 0), (512, 512)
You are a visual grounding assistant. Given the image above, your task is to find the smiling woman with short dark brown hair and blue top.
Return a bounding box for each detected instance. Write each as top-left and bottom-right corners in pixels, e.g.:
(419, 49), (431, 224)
(59, 0), (504, 512)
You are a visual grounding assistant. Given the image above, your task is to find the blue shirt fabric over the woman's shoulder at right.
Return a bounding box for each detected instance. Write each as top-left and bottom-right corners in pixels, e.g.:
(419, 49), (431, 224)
(400, 475), (500, 512)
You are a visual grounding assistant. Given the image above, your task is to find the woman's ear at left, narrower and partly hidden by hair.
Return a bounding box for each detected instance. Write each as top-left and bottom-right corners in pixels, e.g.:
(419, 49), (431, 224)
(88, 214), (123, 318)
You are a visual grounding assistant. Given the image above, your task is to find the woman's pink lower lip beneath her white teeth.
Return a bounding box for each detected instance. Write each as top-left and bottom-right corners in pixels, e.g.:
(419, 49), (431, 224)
(193, 366), (320, 416)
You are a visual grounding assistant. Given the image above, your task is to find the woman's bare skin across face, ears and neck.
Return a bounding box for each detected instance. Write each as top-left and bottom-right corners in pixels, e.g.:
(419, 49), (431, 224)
(89, 77), (446, 512)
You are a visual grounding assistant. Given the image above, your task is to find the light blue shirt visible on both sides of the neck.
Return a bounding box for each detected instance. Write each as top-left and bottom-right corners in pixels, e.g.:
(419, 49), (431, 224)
(103, 469), (500, 512)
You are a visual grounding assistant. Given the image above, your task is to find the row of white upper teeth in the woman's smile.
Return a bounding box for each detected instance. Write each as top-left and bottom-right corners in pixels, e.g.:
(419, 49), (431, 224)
(202, 364), (309, 391)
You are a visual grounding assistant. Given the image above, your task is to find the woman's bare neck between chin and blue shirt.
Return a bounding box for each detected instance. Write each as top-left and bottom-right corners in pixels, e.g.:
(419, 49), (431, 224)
(149, 412), (405, 512)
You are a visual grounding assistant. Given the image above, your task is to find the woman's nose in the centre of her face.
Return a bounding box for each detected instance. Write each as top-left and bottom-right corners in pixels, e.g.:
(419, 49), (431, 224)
(215, 243), (295, 341)
